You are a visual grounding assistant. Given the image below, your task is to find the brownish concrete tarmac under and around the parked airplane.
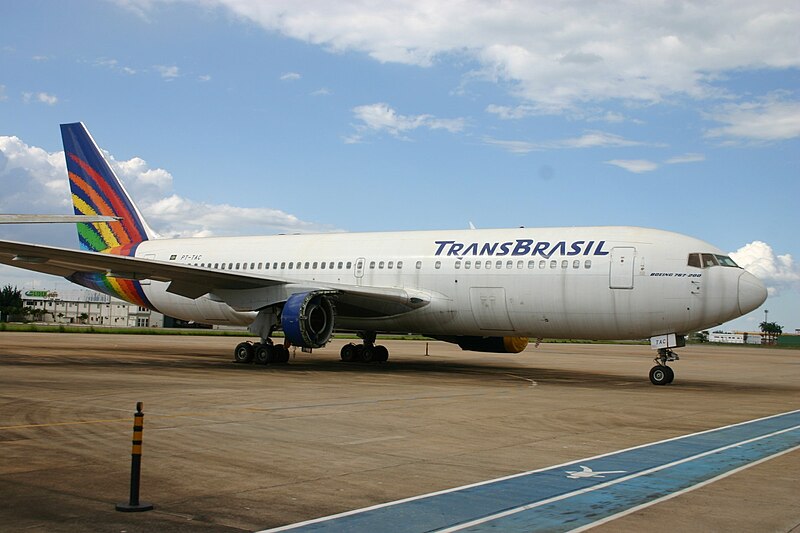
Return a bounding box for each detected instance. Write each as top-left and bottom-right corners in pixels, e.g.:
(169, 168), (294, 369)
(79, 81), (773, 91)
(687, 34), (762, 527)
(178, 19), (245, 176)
(0, 332), (800, 532)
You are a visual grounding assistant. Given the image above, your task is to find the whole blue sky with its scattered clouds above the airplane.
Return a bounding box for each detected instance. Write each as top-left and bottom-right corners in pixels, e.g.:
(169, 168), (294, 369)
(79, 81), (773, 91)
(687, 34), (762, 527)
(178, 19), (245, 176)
(0, 0), (800, 331)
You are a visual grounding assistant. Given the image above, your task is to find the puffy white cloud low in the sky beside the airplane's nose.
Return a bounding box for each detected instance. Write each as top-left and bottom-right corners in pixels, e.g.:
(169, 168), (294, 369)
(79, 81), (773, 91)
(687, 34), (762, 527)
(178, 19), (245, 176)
(730, 241), (800, 295)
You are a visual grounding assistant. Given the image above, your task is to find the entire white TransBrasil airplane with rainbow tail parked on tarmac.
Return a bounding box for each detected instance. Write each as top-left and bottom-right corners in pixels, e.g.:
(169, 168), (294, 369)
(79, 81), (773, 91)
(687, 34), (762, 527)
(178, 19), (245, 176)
(0, 122), (767, 385)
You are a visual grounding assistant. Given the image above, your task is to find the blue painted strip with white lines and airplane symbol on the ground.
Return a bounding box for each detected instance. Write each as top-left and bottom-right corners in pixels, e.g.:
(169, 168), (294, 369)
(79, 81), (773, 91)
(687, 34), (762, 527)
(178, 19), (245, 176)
(270, 410), (800, 532)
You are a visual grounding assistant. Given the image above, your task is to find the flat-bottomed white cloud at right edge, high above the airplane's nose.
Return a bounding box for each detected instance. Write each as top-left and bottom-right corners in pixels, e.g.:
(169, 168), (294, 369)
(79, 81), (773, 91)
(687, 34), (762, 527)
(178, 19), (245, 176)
(706, 93), (800, 141)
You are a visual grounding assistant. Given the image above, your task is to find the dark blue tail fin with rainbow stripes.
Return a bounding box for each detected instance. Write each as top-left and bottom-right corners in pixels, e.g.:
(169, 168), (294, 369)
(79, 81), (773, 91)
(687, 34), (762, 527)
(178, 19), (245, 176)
(61, 122), (156, 251)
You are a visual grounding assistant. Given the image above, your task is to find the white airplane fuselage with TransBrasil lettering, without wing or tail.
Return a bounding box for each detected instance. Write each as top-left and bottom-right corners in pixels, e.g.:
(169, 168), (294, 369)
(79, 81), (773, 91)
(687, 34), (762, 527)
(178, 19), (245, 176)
(130, 227), (763, 339)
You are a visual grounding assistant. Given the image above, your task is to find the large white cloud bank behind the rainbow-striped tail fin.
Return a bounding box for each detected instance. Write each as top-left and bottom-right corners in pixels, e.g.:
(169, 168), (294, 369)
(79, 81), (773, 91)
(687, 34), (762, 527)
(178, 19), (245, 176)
(0, 136), (332, 242)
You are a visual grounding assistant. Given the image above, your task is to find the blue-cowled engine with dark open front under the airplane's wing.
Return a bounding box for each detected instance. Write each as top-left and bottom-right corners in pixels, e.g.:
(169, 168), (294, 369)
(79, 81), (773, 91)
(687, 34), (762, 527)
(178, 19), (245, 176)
(281, 291), (336, 348)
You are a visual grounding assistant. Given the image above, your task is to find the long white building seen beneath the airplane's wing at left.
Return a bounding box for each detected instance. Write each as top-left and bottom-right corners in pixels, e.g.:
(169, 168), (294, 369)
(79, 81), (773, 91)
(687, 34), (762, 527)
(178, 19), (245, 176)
(22, 289), (164, 328)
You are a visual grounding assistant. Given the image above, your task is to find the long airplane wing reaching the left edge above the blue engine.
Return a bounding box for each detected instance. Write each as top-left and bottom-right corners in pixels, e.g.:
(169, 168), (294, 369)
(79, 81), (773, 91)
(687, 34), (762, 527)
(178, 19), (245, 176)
(0, 241), (431, 317)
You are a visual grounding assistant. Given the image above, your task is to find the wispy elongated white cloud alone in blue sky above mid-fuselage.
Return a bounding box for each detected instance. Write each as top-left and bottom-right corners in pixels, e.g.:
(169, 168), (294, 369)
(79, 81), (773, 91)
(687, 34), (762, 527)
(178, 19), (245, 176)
(352, 103), (466, 142)
